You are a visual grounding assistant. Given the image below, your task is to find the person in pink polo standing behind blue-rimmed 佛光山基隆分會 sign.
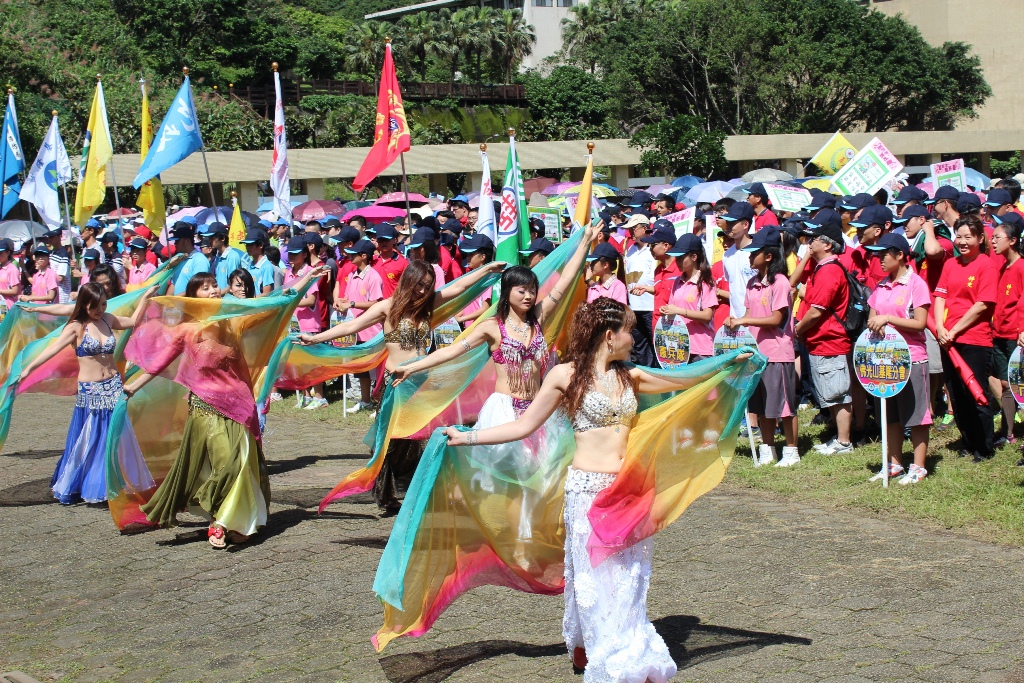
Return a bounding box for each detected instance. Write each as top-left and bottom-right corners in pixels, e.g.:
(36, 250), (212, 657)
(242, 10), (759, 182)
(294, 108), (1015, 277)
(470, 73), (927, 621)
(867, 232), (932, 484)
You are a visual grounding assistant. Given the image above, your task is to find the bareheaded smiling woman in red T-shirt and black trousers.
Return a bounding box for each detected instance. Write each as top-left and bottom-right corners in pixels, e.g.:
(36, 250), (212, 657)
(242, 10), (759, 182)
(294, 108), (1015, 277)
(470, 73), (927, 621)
(935, 215), (998, 462)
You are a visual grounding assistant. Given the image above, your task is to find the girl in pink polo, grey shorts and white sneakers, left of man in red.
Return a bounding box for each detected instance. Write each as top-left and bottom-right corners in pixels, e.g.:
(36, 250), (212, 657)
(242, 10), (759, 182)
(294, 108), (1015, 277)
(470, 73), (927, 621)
(723, 225), (800, 467)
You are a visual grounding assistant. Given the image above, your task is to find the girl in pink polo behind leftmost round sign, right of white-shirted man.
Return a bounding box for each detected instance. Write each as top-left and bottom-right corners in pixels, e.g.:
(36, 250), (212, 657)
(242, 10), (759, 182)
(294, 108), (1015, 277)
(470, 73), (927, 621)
(657, 232), (718, 362)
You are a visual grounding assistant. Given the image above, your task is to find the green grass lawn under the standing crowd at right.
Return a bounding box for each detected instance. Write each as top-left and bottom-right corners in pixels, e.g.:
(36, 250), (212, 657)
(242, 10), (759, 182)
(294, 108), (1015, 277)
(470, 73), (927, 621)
(726, 411), (1024, 546)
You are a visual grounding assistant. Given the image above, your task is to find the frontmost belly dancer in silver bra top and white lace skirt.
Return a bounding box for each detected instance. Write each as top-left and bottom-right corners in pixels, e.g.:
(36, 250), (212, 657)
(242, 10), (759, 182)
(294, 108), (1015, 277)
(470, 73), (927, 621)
(445, 297), (716, 683)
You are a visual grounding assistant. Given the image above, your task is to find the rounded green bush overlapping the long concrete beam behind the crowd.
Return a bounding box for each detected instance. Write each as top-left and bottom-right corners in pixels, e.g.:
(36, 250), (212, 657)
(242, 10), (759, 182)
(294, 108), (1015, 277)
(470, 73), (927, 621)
(629, 116), (726, 178)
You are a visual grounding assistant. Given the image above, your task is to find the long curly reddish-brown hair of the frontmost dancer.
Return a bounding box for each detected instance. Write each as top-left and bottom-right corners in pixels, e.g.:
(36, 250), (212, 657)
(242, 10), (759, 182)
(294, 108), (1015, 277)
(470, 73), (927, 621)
(564, 297), (637, 416)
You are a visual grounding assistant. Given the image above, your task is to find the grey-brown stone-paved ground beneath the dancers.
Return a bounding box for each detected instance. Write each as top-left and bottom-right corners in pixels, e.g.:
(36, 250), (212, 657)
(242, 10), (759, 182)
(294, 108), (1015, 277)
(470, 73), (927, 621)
(0, 396), (1024, 683)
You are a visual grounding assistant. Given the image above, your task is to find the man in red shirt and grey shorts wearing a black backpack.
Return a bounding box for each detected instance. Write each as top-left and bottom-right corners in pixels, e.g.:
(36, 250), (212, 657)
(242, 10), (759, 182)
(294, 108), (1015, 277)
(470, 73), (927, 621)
(794, 211), (853, 456)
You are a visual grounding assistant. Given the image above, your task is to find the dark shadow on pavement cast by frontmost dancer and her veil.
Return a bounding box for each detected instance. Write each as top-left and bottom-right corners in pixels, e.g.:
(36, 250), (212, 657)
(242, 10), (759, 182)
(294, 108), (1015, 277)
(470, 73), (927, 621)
(380, 618), (811, 683)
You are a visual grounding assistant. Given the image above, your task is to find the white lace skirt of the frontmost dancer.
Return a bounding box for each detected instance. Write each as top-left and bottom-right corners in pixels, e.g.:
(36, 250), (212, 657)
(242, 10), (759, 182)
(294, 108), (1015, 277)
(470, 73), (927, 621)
(562, 467), (676, 683)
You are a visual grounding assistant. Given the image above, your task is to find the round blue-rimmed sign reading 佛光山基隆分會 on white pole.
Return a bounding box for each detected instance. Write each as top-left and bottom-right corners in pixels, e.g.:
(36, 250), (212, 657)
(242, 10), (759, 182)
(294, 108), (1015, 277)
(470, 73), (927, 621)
(853, 325), (910, 487)
